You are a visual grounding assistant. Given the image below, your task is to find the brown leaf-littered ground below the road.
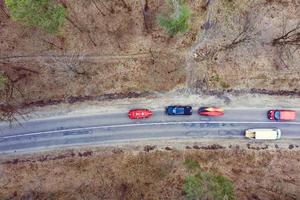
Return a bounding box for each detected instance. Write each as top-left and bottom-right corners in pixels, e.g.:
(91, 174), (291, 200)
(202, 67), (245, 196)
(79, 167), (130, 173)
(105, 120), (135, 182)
(0, 144), (300, 200)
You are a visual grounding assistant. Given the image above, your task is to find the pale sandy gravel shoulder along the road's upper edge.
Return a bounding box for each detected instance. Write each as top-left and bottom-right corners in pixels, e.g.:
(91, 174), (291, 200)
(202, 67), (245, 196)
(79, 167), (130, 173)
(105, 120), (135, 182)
(9, 91), (300, 121)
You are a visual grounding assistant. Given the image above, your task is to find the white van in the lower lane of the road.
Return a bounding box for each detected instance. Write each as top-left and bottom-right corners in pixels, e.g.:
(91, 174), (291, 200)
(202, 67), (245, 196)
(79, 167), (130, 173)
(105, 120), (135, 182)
(245, 128), (281, 140)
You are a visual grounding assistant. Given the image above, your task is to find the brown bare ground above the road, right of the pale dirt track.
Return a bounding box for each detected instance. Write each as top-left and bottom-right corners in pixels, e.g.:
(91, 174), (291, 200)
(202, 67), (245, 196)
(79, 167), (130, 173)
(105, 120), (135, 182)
(191, 0), (300, 91)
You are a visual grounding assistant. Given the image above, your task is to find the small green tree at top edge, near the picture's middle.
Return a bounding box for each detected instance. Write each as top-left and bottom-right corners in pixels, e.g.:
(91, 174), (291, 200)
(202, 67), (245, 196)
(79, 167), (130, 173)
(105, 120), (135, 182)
(158, 0), (191, 36)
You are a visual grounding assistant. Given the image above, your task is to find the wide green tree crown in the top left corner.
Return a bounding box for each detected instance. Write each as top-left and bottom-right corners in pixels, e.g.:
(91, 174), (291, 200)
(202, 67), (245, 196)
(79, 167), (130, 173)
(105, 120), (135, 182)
(5, 0), (66, 33)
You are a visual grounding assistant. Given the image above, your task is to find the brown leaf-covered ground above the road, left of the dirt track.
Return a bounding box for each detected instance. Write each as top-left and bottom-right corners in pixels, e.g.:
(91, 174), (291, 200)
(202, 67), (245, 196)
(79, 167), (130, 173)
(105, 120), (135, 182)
(0, 0), (201, 108)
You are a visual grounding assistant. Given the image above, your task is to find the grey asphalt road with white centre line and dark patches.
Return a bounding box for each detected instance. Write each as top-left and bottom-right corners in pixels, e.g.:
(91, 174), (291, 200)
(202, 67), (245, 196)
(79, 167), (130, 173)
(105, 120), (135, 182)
(0, 109), (300, 152)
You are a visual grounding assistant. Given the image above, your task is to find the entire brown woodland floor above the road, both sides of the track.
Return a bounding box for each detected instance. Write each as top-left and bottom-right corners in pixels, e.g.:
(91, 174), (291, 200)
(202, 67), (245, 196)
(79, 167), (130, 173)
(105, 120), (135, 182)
(0, 0), (300, 112)
